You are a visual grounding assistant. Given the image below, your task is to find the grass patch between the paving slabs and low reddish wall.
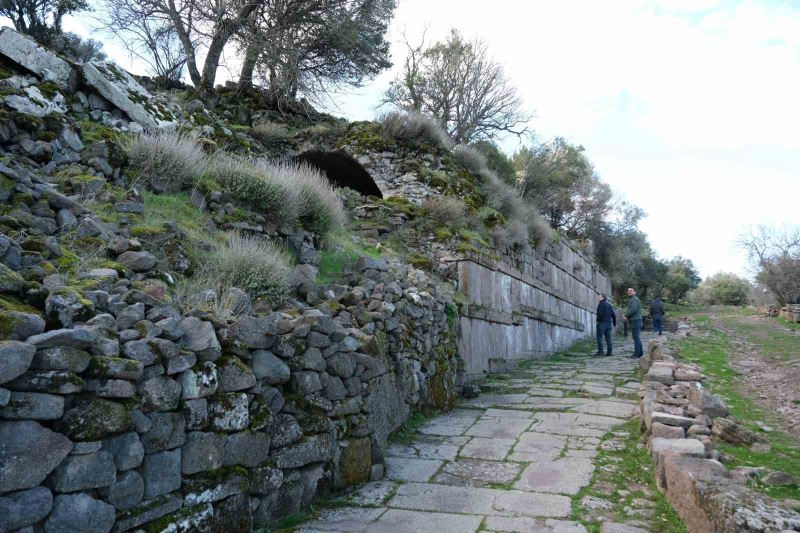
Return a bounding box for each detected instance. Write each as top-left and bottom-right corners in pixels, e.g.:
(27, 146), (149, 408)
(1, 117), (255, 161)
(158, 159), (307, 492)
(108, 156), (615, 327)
(572, 420), (686, 533)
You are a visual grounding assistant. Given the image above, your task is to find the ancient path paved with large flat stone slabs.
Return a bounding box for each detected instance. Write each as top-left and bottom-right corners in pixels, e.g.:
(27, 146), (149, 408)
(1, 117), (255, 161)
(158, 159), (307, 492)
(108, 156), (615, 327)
(295, 330), (656, 533)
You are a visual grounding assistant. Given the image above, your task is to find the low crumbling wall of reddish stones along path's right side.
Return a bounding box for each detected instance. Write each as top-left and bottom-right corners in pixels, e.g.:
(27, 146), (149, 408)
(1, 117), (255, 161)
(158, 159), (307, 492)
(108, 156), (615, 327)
(640, 337), (800, 533)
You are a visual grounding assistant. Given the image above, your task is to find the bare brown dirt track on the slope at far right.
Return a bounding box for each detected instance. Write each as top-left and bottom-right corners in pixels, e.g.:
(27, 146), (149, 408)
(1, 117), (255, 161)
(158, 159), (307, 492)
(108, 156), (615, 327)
(710, 311), (800, 439)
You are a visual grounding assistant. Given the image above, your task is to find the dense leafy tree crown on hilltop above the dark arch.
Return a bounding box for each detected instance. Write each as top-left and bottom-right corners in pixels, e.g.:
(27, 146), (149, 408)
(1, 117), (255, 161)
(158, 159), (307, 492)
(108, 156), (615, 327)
(237, 0), (396, 108)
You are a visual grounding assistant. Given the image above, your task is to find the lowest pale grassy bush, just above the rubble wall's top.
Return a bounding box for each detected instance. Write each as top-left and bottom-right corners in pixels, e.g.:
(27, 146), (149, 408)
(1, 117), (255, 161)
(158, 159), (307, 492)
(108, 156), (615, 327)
(201, 233), (292, 301)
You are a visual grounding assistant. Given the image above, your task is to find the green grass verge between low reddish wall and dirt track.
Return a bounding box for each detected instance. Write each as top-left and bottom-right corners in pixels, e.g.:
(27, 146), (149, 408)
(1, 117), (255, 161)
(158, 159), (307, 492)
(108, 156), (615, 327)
(674, 308), (800, 499)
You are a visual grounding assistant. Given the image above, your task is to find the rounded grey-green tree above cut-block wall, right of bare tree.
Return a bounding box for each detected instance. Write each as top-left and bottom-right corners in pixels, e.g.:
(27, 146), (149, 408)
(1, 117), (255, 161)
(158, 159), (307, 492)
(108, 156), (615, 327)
(513, 137), (616, 239)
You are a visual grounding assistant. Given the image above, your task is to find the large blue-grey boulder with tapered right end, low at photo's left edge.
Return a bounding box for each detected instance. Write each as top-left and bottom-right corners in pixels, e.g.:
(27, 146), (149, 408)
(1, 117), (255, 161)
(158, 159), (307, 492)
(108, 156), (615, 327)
(0, 421), (73, 493)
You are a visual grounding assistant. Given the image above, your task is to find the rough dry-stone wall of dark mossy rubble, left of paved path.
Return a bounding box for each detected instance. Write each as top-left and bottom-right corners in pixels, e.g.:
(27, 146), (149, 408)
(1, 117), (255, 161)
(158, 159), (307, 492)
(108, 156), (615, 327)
(0, 258), (458, 532)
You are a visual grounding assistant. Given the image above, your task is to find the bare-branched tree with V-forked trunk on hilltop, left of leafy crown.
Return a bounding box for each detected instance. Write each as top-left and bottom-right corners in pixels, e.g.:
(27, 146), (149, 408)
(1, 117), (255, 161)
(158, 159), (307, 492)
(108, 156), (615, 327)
(103, 0), (260, 94)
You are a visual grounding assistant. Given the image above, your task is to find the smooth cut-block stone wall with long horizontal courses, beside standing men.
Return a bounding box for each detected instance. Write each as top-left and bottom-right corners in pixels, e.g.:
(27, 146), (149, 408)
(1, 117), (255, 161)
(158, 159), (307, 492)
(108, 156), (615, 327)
(453, 241), (611, 377)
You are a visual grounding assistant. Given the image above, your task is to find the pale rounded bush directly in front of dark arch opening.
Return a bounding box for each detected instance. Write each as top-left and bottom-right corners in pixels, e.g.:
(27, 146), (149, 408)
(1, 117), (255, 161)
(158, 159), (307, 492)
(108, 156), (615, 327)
(256, 159), (346, 234)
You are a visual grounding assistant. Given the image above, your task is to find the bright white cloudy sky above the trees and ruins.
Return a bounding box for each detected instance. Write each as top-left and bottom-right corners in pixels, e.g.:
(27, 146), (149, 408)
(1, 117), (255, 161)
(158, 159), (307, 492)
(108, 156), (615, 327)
(34, 0), (800, 276)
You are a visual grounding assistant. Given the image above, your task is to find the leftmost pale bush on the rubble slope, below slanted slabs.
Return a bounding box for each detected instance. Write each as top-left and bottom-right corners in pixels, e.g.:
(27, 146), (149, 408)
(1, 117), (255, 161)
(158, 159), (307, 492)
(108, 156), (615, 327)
(125, 132), (208, 192)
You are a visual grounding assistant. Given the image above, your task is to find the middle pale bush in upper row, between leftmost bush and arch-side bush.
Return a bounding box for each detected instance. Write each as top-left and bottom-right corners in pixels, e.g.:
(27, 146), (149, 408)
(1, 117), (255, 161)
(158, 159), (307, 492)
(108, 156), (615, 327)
(208, 152), (300, 223)
